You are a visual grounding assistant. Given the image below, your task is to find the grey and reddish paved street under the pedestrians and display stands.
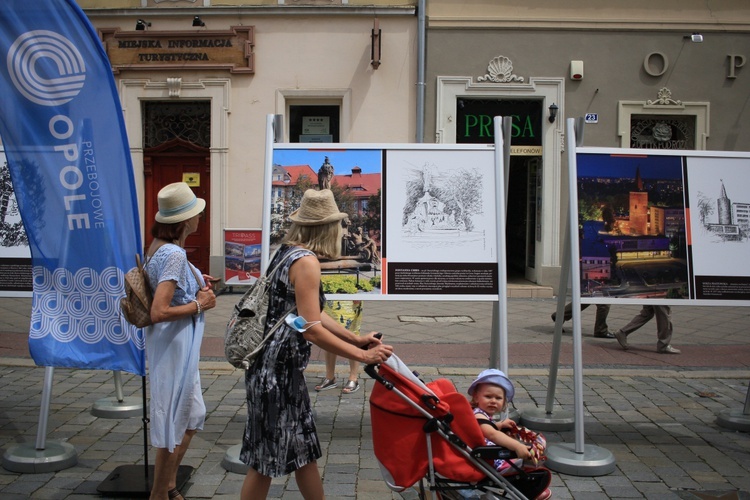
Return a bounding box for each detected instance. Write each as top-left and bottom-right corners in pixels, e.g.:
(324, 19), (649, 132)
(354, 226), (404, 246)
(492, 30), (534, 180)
(0, 293), (750, 499)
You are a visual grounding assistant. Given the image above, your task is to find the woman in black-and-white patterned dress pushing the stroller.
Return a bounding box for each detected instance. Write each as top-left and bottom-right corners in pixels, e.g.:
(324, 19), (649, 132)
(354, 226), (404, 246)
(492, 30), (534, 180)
(240, 189), (393, 500)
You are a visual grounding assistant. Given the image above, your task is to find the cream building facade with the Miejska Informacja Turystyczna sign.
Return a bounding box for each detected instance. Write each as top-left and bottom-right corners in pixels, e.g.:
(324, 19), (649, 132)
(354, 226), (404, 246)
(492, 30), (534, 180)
(77, 0), (417, 276)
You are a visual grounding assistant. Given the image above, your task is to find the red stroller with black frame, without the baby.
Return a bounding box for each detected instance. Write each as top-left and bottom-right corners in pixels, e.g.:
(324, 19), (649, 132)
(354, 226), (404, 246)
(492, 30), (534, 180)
(365, 355), (551, 499)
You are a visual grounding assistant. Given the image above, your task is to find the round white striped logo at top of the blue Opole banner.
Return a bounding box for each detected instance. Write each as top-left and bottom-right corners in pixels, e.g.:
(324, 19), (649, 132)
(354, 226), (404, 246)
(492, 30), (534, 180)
(7, 30), (86, 106)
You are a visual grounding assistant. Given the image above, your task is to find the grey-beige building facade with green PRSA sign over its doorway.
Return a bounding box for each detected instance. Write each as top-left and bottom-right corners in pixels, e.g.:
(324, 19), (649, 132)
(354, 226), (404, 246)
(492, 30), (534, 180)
(425, 0), (750, 289)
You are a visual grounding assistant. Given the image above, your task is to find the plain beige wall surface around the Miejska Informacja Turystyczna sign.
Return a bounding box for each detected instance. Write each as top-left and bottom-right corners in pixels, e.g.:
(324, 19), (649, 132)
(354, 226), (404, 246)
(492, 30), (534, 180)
(88, 9), (417, 274)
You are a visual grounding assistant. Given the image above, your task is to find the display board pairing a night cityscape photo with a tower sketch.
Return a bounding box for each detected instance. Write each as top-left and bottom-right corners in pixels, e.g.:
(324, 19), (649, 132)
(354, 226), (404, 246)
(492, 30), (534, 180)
(574, 148), (750, 305)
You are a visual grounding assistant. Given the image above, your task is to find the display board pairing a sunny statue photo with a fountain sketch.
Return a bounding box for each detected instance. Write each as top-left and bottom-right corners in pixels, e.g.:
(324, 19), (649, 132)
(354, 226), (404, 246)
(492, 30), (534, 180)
(267, 144), (498, 300)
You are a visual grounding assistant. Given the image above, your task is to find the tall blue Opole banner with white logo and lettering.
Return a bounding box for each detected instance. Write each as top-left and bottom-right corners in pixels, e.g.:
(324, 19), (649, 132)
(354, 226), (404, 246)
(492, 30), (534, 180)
(0, 0), (145, 375)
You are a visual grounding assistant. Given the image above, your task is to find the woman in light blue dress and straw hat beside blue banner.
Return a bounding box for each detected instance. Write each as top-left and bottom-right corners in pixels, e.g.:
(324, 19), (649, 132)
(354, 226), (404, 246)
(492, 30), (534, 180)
(145, 182), (216, 500)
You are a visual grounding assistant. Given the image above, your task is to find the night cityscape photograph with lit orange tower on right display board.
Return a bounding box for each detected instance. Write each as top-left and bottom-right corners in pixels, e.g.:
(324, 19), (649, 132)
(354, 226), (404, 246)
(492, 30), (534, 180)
(577, 153), (690, 299)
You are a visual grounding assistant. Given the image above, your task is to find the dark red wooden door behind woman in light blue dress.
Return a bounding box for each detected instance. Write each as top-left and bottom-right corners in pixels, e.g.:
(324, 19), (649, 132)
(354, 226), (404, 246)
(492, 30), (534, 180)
(144, 139), (211, 273)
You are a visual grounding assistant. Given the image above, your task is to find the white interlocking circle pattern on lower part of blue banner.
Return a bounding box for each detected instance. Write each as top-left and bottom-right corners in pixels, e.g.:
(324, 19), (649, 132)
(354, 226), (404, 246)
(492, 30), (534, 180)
(29, 266), (145, 349)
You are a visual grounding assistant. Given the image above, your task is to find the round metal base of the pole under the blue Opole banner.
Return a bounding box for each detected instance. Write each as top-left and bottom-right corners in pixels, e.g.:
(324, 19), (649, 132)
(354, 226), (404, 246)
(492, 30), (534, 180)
(3, 441), (78, 474)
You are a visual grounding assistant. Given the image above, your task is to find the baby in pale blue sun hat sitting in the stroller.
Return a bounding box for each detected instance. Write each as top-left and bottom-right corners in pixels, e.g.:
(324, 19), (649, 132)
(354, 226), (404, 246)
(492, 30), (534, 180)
(468, 368), (552, 500)
